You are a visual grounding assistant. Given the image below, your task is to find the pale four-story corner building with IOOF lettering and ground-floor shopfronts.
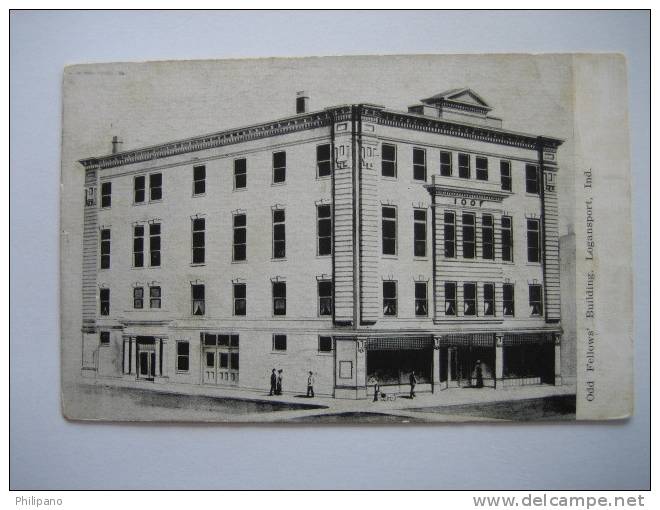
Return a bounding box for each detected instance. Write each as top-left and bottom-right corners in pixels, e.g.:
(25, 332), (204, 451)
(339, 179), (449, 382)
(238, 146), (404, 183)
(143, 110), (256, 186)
(80, 89), (562, 398)
